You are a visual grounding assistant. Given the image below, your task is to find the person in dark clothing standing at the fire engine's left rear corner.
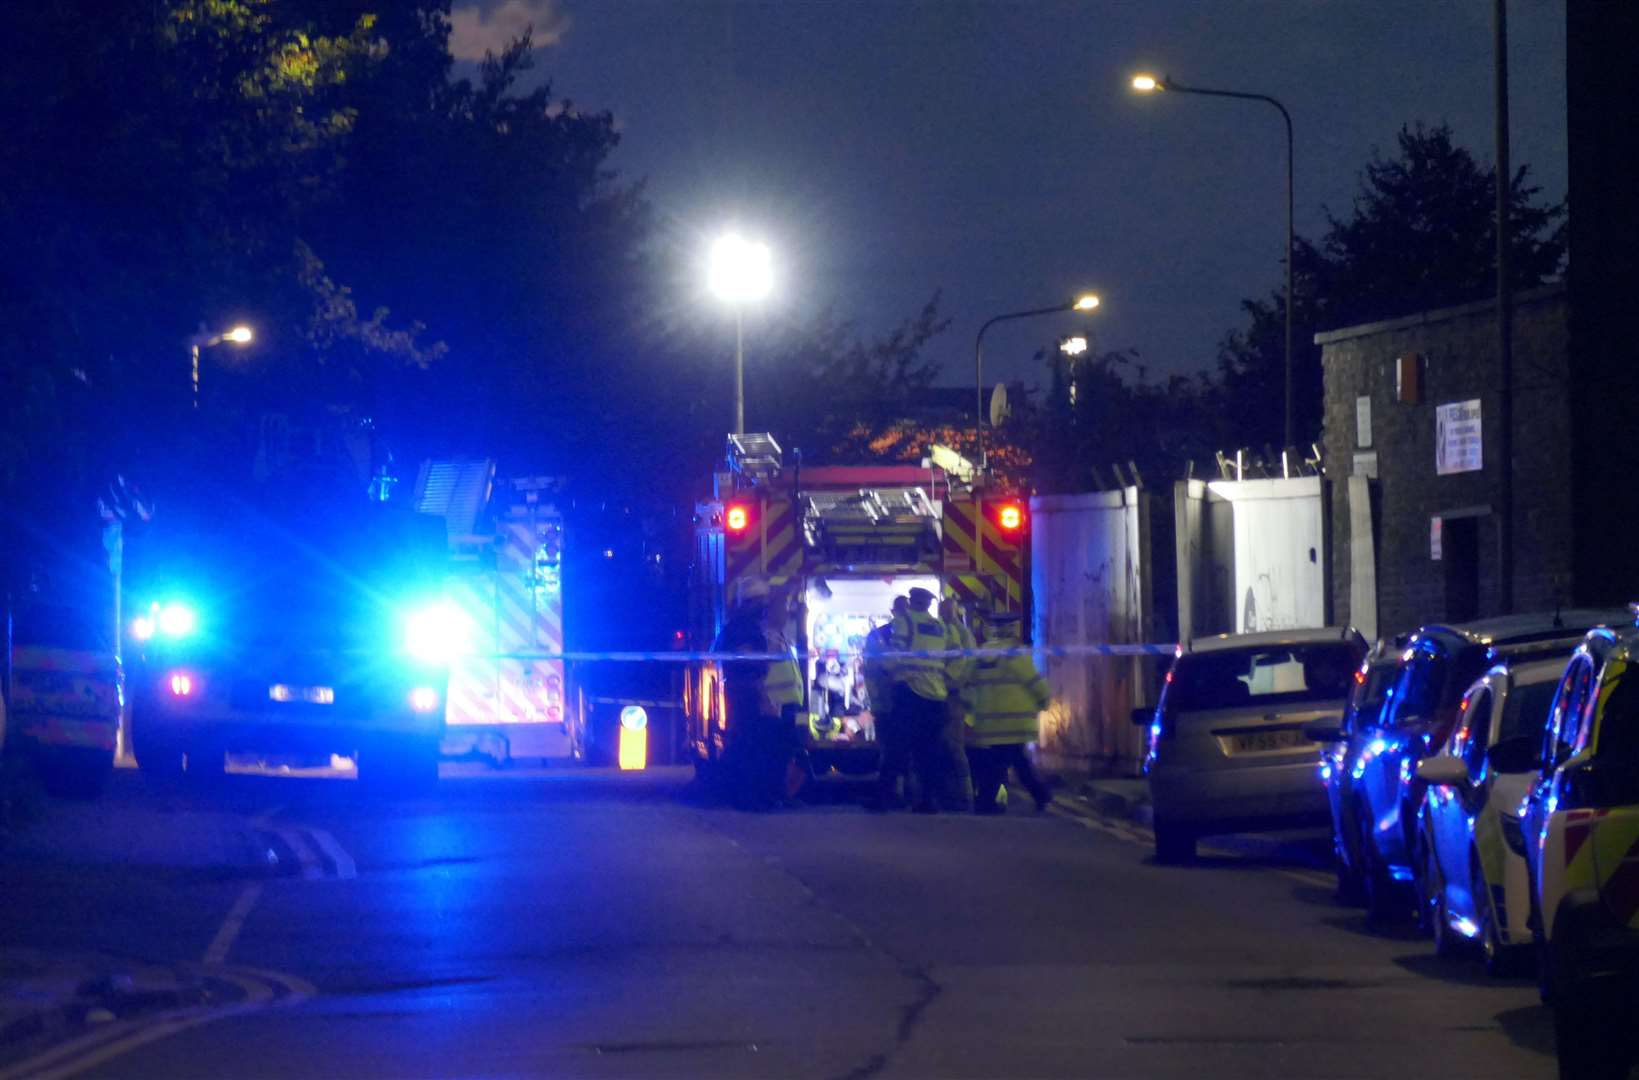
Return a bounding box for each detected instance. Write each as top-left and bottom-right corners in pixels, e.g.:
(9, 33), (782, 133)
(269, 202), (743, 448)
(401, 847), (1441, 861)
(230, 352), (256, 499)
(713, 579), (803, 810)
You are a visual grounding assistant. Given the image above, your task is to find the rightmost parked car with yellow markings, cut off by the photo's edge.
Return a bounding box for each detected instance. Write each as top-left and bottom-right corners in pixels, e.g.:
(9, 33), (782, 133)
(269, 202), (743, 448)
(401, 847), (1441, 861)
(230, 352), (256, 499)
(1521, 619), (1639, 1008)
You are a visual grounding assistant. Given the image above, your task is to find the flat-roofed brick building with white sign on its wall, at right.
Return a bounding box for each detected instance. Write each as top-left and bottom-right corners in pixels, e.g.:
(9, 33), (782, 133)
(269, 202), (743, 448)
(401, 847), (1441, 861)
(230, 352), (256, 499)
(1314, 285), (1573, 634)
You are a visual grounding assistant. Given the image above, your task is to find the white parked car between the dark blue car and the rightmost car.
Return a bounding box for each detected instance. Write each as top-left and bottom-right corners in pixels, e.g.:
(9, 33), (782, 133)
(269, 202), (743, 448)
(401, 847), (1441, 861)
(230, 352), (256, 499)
(1416, 660), (1565, 975)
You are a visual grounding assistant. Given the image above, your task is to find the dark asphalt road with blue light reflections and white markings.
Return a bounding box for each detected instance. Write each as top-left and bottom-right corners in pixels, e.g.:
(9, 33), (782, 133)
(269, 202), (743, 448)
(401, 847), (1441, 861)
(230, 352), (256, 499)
(0, 767), (1554, 1078)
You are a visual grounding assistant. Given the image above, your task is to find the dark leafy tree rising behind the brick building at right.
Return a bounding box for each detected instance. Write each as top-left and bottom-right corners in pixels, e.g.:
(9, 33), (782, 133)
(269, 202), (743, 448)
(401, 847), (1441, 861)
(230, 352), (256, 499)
(1213, 125), (1565, 447)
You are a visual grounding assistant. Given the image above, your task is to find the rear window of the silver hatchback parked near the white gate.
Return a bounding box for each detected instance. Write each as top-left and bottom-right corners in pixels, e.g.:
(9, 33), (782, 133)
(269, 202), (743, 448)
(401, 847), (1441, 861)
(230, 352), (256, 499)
(1167, 642), (1360, 710)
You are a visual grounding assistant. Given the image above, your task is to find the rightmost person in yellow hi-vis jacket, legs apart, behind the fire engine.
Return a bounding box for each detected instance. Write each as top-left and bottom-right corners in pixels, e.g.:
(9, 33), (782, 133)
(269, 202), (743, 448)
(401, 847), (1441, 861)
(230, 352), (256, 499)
(967, 611), (1052, 815)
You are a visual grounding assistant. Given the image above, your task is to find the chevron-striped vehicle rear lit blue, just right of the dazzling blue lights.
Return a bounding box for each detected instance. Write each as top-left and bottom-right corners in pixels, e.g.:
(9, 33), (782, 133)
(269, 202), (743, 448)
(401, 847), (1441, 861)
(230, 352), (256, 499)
(415, 461), (574, 760)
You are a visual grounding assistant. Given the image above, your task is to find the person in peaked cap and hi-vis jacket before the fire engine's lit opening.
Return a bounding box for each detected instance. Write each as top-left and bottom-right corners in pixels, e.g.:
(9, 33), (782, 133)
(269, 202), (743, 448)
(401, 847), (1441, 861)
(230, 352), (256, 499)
(890, 588), (967, 813)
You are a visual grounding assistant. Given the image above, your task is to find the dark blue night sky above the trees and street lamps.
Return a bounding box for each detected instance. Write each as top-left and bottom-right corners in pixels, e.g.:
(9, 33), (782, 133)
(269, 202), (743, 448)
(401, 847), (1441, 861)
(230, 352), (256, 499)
(452, 0), (1565, 383)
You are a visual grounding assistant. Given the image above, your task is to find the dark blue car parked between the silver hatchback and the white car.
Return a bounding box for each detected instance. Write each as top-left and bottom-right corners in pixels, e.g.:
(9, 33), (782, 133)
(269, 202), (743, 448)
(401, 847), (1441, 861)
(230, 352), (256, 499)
(1310, 611), (1624, 919)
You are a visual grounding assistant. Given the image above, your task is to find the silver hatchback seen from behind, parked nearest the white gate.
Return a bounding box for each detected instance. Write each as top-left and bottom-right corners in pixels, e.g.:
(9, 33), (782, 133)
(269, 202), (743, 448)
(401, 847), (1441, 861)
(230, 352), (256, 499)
(1134, 628), (1365, 862)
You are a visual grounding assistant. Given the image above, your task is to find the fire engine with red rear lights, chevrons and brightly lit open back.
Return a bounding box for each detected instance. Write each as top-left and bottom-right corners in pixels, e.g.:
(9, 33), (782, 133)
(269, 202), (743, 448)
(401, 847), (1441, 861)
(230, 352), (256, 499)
(683, 434), (1029, 777)
